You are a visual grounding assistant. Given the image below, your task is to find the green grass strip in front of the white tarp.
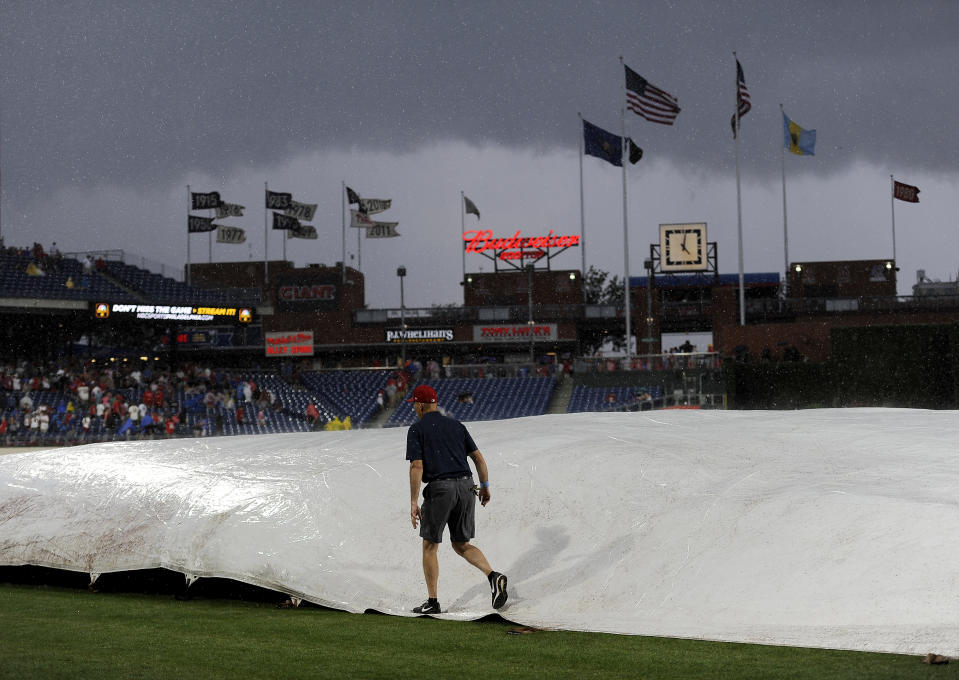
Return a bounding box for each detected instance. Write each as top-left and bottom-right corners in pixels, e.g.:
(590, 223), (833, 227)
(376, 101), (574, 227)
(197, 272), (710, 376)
(0, 583), (959, 680)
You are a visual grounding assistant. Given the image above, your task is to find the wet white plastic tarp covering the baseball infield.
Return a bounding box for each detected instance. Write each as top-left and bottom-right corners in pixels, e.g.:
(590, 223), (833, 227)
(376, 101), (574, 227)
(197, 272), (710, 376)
(0, 409), (959, 656)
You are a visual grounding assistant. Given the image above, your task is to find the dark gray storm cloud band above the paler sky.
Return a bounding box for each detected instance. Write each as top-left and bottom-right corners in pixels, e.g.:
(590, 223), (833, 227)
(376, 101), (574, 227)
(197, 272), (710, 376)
(0, 0), (959, 202)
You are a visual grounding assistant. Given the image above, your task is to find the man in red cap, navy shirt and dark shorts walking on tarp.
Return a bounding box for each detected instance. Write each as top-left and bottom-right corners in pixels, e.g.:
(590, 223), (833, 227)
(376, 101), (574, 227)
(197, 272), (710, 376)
(406, 385), (507, 614)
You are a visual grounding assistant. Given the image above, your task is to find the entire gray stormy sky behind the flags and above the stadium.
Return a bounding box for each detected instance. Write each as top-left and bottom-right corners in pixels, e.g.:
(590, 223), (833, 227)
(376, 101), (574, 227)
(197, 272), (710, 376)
(0, 0), (959, 307)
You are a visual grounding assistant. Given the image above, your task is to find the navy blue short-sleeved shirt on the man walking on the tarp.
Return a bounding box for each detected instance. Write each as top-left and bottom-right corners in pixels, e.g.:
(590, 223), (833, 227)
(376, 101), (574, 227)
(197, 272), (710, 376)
(406, 411), (477, 482)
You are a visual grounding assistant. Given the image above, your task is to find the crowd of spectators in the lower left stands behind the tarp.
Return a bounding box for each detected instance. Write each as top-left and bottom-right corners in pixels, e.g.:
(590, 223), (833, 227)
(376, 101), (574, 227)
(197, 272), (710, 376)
(0, 359), (349, 445)
